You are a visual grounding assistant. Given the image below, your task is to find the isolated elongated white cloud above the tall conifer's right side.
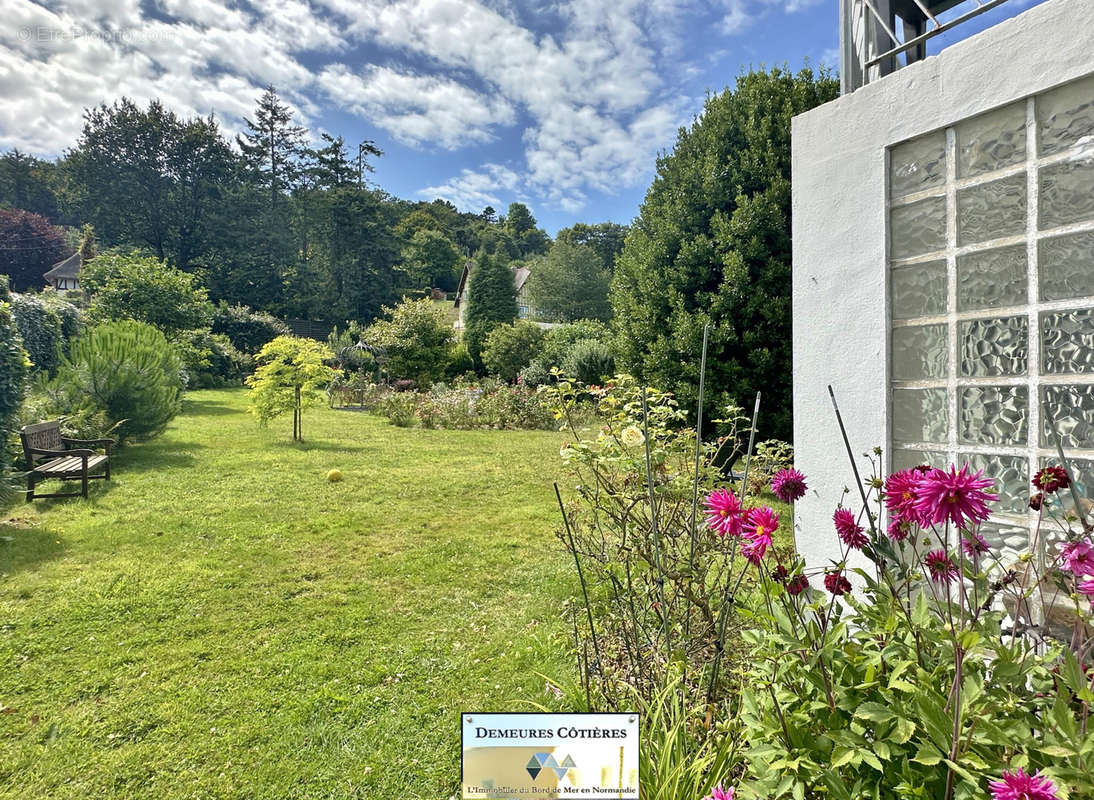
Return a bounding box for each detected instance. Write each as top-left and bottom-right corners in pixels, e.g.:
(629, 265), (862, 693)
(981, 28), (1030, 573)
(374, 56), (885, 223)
(318, 65), (516, 150)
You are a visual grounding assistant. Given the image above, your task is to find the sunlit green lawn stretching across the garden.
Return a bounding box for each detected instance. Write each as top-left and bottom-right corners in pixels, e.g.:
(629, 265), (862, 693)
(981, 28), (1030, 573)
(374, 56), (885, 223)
(0, 390), (574, 800)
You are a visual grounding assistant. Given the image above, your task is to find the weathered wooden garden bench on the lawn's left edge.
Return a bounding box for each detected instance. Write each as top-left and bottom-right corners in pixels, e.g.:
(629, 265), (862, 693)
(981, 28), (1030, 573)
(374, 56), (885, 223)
(19, 420), (114, 502)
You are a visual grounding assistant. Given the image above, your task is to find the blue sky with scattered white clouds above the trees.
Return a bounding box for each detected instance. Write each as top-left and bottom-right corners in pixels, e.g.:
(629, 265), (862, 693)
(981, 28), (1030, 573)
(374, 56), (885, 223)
(0, 0), (1038, 234)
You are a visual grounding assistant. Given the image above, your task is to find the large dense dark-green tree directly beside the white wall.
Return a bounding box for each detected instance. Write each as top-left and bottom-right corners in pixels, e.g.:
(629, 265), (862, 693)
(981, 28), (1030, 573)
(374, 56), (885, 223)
(612, 69), (839, 439)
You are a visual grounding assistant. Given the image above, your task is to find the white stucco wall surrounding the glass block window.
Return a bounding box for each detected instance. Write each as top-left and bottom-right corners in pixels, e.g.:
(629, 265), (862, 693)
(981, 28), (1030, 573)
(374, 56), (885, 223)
(793, 0), (1094, 567)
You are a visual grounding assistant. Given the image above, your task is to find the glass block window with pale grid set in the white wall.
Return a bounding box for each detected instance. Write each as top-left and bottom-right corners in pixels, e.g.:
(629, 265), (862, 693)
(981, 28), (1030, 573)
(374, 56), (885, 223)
(888, 77), (1094, 552)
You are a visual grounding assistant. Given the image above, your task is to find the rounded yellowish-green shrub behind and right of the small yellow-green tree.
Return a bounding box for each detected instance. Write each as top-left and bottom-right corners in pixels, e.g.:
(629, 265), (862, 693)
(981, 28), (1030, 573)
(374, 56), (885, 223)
(365, 299), (455, 386)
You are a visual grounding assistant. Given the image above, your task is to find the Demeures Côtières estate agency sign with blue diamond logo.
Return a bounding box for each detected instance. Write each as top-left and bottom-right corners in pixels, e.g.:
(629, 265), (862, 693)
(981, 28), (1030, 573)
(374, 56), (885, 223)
(461, 712), (639, 800)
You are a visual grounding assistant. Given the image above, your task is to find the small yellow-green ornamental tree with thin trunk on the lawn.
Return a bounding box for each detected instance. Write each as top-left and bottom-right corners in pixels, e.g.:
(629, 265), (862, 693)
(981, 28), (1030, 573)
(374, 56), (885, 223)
(246, 336), (335, 441)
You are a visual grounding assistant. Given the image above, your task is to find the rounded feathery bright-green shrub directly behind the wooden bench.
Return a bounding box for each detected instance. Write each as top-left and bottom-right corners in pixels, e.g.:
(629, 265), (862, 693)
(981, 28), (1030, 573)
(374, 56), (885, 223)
(49, 321), (183, 440)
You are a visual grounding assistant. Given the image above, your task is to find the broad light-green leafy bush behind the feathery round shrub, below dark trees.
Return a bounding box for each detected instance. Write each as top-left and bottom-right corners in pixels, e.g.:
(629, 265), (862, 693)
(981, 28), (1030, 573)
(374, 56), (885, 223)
(80, 253), (212, 335)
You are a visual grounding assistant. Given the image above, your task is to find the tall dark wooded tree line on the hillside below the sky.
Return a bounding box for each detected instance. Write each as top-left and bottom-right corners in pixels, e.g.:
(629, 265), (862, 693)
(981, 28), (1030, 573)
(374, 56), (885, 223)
(0, 86), (626, 322)
